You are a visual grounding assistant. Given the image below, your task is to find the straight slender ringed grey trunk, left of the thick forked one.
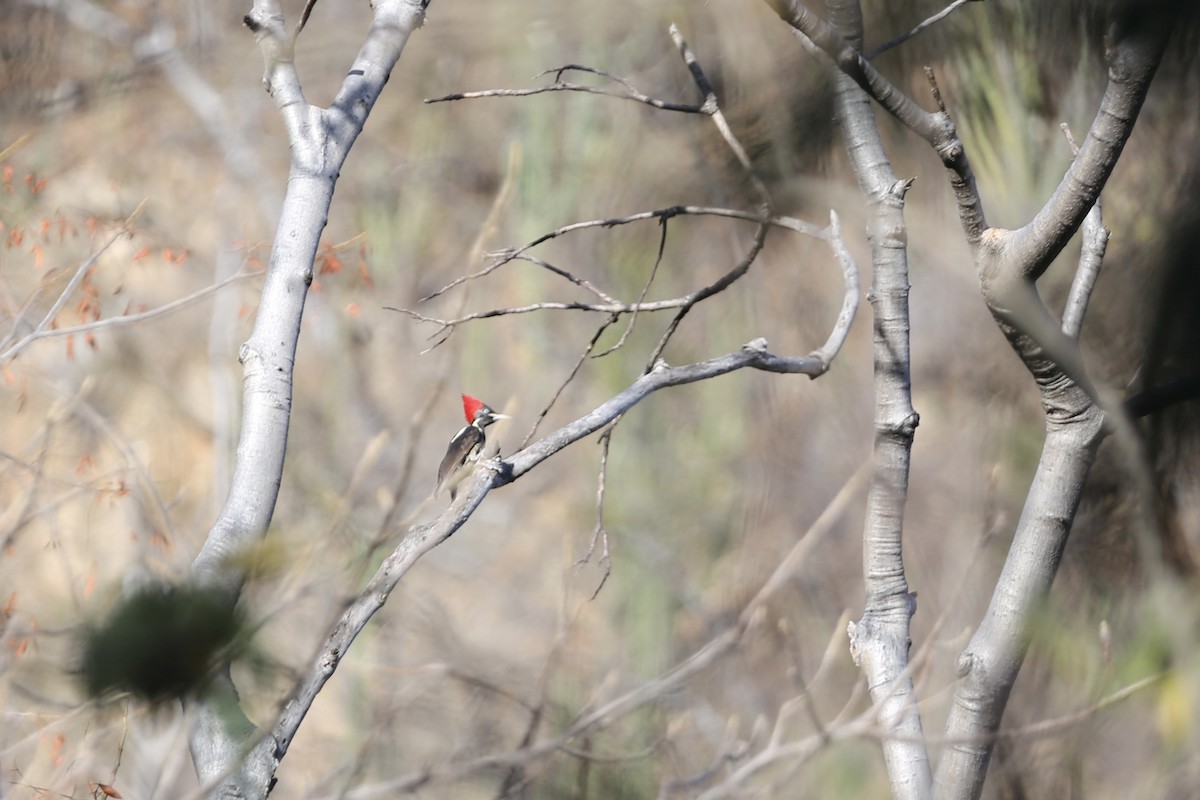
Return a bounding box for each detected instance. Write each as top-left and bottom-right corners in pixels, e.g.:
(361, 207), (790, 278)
(829, 0), (932, 800)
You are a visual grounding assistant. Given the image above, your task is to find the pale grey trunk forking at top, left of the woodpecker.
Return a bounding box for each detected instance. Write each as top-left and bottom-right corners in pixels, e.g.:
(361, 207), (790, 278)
(182, 0), (425, 798)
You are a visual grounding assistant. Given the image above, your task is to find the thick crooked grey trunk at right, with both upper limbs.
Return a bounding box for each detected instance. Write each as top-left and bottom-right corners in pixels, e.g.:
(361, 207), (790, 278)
(768, 0), (1174, 798)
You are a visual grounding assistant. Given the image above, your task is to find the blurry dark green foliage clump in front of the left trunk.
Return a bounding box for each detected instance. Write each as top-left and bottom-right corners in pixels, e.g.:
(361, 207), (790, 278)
(83, 585), (244, 703)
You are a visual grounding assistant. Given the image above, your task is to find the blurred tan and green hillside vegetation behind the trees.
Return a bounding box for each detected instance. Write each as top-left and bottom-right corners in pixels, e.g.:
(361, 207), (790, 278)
(0, 0), (1200, 798)
